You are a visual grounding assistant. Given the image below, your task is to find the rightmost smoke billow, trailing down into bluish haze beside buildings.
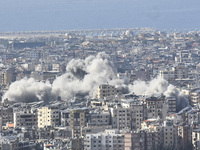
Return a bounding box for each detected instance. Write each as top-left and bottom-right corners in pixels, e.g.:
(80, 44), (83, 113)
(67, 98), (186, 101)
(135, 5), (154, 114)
(129, 77), (188, 110)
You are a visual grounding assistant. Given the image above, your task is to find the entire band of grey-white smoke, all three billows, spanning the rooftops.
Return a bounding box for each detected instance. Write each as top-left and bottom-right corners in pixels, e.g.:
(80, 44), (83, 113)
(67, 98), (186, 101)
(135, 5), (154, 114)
(3, 53), (188, 108)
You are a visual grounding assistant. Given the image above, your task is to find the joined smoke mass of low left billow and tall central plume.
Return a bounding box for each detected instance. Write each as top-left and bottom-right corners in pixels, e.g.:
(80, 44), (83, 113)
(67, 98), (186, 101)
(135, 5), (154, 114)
(3, 53), (126, 102)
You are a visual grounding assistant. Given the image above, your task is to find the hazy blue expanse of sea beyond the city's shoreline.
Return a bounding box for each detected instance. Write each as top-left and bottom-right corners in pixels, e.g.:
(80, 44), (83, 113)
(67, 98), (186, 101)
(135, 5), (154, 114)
(0, 0), (200, 32)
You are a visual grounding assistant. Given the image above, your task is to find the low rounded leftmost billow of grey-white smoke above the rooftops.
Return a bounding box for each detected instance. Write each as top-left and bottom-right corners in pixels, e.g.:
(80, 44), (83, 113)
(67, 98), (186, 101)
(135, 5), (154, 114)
(3, 78), (55, 102)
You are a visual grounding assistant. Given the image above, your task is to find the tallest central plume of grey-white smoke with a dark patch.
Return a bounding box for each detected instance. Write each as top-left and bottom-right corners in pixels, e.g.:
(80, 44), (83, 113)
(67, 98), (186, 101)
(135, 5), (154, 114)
(52, 53), (124, 99)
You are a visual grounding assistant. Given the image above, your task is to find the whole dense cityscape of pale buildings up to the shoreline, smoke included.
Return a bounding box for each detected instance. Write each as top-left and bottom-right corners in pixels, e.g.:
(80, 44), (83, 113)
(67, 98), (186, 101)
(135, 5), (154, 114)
(0, 28), (200, 150)
